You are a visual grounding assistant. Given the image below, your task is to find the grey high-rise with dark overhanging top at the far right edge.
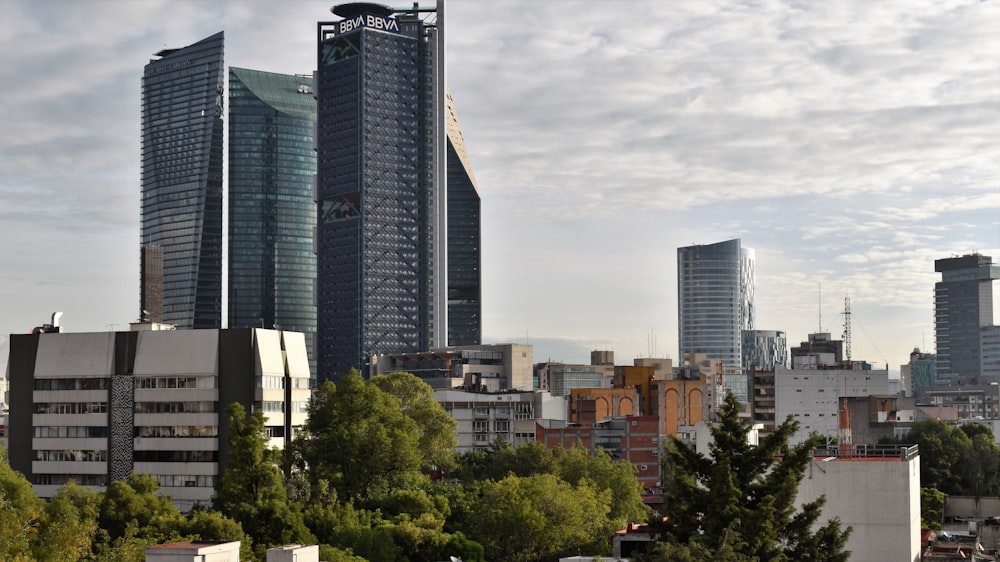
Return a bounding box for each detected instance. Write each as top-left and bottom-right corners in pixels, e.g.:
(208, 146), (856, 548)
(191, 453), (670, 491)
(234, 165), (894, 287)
(934, 254), (1000, 379)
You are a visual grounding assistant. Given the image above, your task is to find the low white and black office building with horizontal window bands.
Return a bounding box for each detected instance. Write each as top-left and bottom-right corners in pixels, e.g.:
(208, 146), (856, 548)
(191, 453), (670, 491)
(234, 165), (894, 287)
(8, 325), (310, 510)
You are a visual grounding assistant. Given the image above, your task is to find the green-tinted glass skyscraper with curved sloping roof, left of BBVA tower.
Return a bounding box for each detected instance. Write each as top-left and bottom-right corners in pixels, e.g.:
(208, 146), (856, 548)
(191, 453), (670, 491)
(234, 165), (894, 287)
(228, 67), (316, 372)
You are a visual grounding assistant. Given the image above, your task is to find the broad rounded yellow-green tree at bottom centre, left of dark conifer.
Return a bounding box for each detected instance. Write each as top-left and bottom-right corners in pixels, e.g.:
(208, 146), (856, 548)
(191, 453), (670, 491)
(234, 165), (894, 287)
(468, 474), (611, 562)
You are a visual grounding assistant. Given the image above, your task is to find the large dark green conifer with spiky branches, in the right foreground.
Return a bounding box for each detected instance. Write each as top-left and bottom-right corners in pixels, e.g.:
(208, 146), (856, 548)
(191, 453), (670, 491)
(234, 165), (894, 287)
(657, 394), (850, 562)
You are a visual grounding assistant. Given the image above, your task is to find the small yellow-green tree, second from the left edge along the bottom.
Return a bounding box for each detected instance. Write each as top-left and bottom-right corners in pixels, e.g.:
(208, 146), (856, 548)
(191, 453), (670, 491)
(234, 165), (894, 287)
(33, 476), (101, 562)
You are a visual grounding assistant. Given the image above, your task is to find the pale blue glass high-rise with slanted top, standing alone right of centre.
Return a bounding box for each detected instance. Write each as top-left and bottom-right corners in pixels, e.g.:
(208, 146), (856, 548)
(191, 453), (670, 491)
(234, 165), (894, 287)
(677, 238), (754, 368)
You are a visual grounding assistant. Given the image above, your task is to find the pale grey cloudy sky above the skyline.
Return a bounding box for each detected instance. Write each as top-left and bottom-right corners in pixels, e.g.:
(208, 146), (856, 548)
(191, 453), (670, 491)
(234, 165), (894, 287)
(0, 0), (1000, 373)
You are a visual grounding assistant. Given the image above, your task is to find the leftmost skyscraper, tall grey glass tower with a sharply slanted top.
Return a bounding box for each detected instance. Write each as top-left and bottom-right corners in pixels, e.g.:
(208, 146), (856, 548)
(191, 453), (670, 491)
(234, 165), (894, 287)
(140, 31), (225, 328)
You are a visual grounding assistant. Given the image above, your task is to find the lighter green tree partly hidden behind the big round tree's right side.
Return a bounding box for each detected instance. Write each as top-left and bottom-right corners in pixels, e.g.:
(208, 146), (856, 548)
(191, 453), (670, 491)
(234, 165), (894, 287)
(371, 373), (458, 470)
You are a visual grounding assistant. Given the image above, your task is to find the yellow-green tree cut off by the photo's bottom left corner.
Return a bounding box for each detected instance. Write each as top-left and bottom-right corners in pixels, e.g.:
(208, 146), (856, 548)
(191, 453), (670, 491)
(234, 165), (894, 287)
(0, 447), (44, 562)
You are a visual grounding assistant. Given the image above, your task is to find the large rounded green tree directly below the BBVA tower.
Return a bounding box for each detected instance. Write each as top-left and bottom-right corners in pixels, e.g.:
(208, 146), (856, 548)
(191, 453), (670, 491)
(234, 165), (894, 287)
(296, 371), (425, 505)
